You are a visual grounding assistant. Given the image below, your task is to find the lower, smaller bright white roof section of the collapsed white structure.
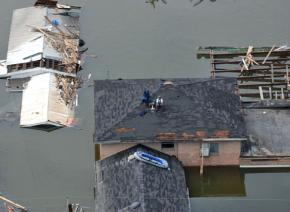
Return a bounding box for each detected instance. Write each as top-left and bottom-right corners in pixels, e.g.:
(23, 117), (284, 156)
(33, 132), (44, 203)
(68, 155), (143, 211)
(20, 73), (73, 127)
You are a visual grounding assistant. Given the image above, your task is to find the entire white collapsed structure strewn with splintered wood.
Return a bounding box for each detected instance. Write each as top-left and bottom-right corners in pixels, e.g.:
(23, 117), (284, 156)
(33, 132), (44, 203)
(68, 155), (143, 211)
(0, 0), (83, 129)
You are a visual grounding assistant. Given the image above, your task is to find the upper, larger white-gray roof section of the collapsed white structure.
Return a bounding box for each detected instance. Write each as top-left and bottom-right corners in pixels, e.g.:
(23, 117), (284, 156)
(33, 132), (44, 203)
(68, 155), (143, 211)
(7, 7), (79, 65)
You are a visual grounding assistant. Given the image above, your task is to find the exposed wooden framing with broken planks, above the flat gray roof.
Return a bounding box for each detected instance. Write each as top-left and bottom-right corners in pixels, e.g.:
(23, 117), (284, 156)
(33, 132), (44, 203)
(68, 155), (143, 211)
(197, 45), (290, 103)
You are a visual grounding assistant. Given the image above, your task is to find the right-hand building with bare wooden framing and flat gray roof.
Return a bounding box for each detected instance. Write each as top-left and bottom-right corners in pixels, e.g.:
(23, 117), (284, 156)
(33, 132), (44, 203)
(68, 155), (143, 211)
(197, 45), (290, 168)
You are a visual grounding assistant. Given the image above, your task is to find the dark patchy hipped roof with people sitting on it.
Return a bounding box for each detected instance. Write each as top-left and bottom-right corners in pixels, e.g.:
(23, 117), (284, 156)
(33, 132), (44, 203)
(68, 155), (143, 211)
(95, 78), (246, 143)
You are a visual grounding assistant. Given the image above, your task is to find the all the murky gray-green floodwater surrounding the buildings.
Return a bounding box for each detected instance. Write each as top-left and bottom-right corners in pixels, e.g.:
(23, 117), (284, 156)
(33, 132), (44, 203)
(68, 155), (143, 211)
(0, 0), (290, 212)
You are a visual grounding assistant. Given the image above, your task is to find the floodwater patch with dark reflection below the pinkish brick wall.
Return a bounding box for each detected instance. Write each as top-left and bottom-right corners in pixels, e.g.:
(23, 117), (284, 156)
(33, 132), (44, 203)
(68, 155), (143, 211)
(189, 168), (290, 212)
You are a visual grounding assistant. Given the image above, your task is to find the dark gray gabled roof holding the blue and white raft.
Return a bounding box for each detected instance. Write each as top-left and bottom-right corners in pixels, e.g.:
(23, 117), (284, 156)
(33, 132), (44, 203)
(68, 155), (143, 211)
(95, 145), (189, 212)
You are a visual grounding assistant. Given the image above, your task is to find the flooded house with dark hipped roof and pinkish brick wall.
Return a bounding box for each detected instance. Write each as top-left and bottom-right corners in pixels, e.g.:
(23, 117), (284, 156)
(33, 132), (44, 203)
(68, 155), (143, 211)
(94, 78), (247, 166)
